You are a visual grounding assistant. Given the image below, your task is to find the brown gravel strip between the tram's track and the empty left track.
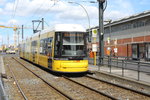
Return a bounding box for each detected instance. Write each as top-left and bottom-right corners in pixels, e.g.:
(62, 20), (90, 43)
(15, 59), (112, 100)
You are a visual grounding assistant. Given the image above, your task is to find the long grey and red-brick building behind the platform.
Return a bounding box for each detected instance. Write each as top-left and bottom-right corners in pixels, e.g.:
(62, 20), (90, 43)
(89, 11), (150, 60)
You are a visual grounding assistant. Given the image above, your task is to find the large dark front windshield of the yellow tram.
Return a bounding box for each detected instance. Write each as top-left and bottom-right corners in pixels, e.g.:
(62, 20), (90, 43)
(55, 32), (86, 57)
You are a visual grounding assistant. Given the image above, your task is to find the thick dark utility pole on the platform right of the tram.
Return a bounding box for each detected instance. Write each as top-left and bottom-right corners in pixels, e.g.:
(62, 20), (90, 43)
(97, 0), (105, 65)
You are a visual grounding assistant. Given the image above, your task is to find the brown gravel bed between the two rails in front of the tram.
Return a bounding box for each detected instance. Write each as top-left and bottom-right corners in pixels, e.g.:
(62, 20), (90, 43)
(65, 76), (150, 100)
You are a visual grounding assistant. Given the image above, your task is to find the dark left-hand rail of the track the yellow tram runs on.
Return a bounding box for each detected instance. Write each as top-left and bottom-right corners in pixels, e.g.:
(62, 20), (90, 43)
(63, 76), (119, 100)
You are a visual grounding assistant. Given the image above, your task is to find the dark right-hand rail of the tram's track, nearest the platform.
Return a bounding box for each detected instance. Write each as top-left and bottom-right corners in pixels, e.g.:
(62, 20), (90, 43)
(85, 75), (150, 97)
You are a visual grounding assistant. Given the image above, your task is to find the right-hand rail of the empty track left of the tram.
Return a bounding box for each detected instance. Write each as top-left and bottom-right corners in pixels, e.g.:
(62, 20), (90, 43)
(12, 57), (74, 100)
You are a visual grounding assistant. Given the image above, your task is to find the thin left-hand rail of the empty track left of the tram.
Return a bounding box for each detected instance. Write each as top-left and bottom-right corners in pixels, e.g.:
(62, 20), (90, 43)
(7, 65), (28, 100)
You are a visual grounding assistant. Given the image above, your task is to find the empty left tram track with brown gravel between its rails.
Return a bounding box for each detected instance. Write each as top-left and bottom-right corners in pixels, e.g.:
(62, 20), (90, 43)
(4, 59), (72, 100)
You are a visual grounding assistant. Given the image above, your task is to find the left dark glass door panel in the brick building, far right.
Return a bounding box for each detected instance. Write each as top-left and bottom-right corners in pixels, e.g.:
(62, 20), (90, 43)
(132, 44), (139, 60)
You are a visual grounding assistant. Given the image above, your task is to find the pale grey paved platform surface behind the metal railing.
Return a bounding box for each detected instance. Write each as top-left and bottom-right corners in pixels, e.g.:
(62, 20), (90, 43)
(89, 64), (150, 84)
